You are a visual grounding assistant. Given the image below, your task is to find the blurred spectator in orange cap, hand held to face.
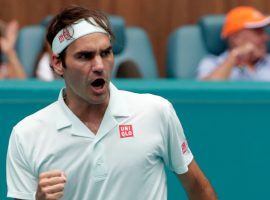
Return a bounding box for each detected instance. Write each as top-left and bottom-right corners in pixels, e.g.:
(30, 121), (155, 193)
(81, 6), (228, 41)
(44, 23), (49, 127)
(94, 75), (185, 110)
(198, 6), (270, 81)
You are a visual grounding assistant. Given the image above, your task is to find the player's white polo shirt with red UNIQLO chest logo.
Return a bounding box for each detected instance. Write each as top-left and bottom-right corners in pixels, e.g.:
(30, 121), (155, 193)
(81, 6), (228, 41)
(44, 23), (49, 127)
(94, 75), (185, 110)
(7, 84), (193, 200)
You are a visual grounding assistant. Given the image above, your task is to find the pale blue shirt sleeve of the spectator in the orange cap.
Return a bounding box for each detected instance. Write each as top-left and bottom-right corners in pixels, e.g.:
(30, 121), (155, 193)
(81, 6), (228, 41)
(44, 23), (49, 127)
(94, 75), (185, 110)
(197, 55), (218, 79)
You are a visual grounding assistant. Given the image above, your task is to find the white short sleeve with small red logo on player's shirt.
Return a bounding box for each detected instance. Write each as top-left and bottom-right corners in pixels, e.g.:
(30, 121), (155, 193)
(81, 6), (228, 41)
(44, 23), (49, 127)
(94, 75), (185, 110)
(163, 103), (193, 174)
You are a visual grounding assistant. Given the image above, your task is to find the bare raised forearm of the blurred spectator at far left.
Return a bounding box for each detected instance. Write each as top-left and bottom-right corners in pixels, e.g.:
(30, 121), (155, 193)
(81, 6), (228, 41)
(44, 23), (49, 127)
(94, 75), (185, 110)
(7, 50), (26, 79)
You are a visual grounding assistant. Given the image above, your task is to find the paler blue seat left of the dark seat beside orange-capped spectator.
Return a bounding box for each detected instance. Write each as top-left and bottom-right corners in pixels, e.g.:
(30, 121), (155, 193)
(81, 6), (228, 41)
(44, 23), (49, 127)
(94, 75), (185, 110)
(166, 25), (207, 79)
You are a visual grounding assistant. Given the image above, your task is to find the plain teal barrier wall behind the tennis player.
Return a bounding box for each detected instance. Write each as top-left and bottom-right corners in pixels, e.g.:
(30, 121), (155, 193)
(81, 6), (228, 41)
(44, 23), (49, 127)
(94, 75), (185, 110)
(0, 80), (270, 200)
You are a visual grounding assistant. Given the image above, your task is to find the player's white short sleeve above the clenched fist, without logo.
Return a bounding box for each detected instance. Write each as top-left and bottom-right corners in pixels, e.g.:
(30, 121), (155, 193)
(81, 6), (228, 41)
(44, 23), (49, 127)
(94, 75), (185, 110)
(6, 129), (37, 199)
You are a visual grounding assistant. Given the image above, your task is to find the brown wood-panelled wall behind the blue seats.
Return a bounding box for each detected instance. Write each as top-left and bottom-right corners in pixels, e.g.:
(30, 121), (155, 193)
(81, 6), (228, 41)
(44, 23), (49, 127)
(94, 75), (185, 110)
(0, 0), (270, 77)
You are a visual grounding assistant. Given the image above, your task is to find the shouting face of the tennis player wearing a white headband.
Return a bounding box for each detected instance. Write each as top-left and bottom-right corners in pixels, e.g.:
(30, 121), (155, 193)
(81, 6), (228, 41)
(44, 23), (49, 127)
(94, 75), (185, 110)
(54, 33), (114, 104)
